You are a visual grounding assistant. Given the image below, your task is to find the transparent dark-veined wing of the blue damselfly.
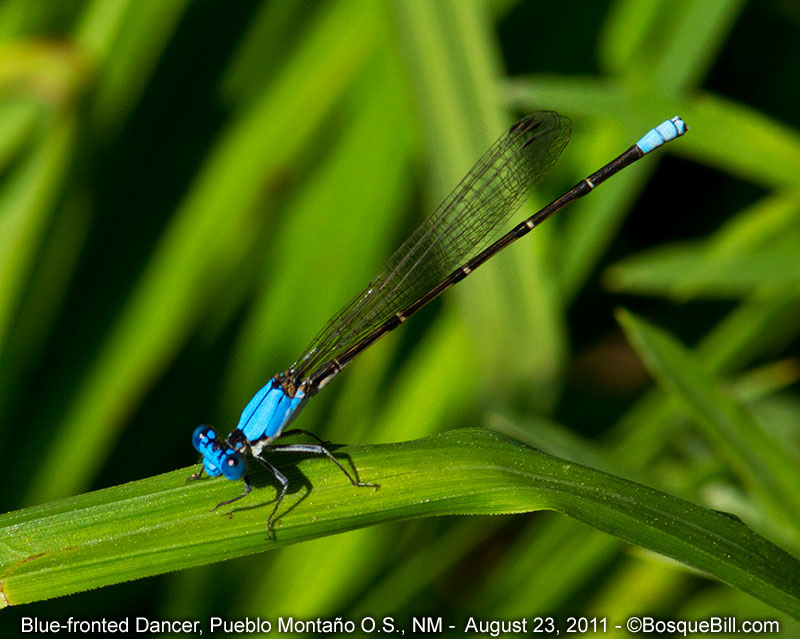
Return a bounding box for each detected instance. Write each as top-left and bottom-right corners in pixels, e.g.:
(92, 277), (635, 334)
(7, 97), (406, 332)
(289, 111), (571, 382)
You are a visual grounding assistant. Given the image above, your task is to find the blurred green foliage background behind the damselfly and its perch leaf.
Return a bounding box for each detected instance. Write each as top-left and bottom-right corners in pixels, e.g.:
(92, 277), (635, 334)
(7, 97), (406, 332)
(0, 0), (800, 636)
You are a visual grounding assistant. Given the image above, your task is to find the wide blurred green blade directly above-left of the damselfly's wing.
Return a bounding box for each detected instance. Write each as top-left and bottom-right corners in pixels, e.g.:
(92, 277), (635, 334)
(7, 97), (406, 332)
(224, 56), (411, 412)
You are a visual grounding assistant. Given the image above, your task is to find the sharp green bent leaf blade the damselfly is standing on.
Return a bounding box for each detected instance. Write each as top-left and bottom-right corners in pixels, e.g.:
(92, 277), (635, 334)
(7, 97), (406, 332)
(0, 430), (800, 616)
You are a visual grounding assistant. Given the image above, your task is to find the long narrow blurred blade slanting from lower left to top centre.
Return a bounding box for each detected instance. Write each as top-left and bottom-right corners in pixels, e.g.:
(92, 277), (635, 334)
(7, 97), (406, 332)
(29, 2), (382, 503)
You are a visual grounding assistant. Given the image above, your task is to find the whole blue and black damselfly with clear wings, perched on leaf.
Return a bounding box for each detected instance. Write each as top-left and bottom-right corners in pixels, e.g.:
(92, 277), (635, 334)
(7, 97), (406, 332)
(191, 111), (688, 537)
